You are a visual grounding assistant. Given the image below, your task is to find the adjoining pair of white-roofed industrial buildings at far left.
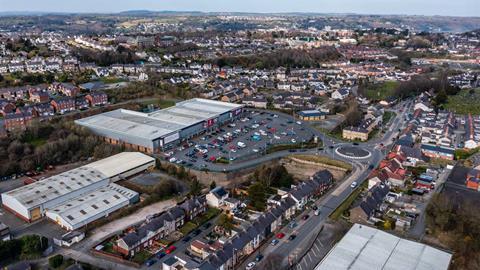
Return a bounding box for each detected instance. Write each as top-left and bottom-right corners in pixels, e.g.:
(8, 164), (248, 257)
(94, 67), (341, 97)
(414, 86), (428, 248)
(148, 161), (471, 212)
(2, 152), (155, 229)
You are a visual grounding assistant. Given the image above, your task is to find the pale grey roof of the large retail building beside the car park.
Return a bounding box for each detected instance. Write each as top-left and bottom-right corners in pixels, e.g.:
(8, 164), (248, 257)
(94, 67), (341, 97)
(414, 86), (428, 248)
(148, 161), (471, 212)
(75, 98), (243, 140)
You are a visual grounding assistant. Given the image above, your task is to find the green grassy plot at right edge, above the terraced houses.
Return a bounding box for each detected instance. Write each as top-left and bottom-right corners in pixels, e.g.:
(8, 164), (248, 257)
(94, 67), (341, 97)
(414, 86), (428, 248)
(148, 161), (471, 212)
(444, 88), (480, 115)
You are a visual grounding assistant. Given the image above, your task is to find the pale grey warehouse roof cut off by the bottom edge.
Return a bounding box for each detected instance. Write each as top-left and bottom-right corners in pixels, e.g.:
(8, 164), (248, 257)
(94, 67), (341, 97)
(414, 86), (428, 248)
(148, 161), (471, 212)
(315, 224), (452, 270)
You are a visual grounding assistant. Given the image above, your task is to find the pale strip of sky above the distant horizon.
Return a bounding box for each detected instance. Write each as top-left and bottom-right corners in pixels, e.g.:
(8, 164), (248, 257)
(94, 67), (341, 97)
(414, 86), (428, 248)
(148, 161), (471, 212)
(0, 0), (480, 16)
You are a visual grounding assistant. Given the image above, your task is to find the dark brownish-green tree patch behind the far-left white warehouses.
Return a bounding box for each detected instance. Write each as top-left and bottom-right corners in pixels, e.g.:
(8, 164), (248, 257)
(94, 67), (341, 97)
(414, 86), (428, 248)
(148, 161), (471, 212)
(0, 120), (122, 177)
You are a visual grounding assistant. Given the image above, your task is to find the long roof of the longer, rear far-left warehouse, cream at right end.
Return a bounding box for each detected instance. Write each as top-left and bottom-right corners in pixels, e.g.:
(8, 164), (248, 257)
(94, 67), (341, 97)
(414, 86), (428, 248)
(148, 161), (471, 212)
(2, 152), (155, 209)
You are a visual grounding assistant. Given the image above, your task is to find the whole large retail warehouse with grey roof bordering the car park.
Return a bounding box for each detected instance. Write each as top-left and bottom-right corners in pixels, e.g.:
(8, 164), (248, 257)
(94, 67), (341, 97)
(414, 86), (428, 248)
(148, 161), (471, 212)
(75, 98), (244, 153)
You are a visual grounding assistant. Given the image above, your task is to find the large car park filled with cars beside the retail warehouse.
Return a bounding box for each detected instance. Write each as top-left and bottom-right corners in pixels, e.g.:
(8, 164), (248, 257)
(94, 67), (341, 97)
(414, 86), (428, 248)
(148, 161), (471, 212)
(165, 111), (313, 169)
